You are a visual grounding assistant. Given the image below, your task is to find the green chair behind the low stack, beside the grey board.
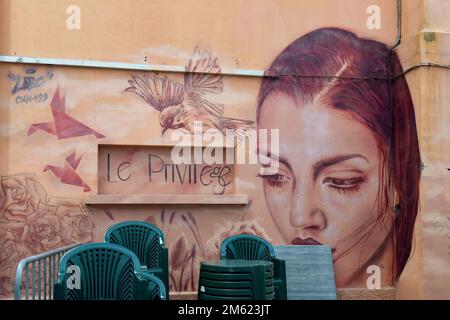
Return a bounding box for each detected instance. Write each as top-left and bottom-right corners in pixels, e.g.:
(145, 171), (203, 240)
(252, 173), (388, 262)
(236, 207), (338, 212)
(220, 234), (287, 300)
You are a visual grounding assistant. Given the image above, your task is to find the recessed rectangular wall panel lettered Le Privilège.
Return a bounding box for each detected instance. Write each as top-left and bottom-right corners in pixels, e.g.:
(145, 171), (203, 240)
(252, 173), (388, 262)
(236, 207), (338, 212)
(98, 145), (234, 195)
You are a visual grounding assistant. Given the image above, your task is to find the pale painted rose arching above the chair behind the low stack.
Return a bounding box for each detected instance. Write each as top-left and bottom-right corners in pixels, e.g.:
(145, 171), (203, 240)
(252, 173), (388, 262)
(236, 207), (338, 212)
(206, 220), (272, 260)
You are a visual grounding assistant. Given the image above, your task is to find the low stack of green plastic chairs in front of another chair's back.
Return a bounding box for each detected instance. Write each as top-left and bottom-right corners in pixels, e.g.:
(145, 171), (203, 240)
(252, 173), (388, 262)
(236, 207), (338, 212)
(198, 260), (274, 300)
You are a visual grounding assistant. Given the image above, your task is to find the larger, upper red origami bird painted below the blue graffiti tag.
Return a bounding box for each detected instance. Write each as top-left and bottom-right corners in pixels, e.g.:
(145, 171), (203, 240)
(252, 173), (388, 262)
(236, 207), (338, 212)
(28, 87), (106, 140)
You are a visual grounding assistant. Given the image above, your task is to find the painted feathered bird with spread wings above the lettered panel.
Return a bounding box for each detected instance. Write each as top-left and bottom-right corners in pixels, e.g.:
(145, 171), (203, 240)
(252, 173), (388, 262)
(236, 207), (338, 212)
(125, 47), (254, 134)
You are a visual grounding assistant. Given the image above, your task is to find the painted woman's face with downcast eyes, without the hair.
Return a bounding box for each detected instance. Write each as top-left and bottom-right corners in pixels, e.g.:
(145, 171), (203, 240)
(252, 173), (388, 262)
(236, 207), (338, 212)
(258, 93), (391, 286)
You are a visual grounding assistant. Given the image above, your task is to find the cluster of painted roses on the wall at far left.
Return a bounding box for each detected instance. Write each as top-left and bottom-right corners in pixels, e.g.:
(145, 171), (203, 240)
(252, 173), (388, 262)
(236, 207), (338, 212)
(0, 174), (94, 296)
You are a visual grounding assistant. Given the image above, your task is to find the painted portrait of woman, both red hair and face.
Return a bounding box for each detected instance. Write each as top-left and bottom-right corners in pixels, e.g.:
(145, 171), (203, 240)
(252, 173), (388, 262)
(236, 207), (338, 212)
(257, 28), (420, 287)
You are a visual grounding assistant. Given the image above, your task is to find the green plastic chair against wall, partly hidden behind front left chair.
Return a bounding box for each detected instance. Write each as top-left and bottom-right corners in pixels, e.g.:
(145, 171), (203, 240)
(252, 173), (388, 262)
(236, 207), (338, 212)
(105, 221), (169, 288)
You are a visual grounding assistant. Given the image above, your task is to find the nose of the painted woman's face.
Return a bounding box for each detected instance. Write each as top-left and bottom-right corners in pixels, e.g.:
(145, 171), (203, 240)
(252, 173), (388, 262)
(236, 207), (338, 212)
(290, 185), (327, 232)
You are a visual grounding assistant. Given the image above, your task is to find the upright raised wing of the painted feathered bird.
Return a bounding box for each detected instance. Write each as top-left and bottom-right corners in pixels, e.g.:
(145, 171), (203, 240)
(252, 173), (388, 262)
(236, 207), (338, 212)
(184, 47), (223, 95)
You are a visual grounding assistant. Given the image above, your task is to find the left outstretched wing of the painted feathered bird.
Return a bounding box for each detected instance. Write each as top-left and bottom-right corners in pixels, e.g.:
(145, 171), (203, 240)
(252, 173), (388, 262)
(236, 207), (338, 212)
(125, 75), (184, 111)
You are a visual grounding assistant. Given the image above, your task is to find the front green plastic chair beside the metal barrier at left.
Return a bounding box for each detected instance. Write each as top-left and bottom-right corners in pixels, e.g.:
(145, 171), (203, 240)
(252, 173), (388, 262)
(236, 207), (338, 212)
(54, 243), (167, 300)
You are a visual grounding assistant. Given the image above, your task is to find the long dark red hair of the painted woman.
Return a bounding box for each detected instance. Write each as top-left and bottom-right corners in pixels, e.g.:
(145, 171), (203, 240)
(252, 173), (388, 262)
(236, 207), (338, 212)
(257, 28), (421, 279)
